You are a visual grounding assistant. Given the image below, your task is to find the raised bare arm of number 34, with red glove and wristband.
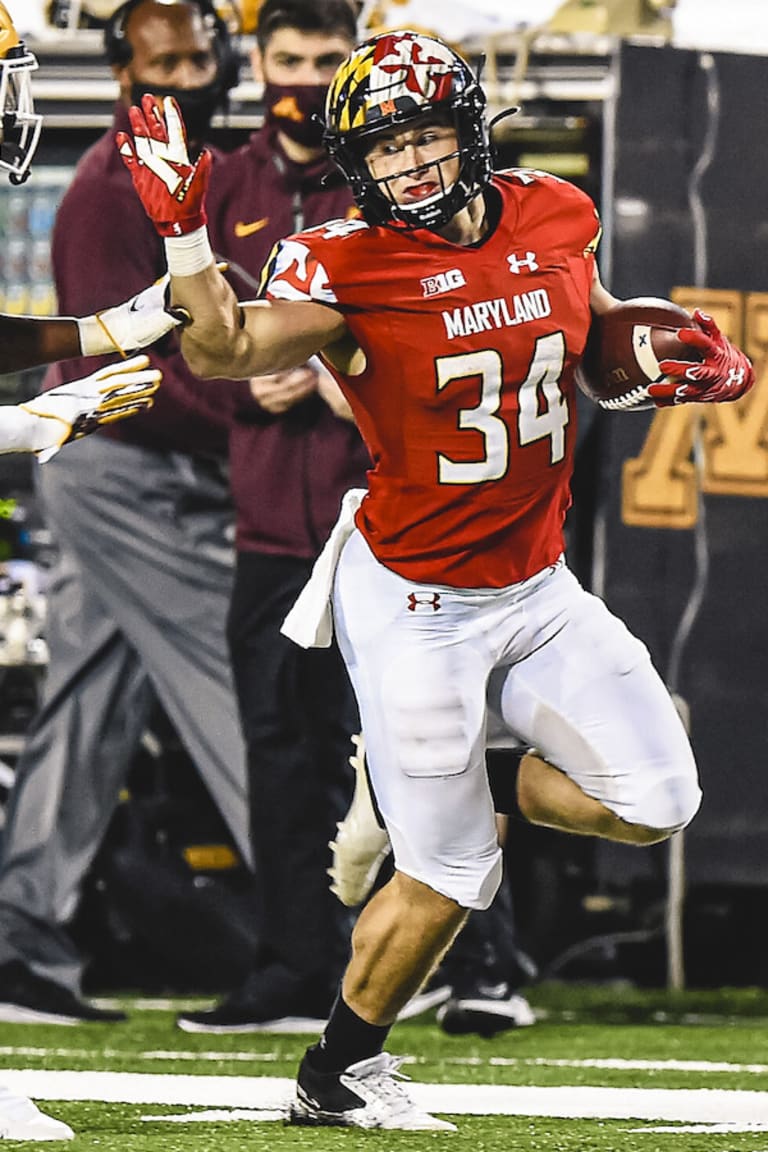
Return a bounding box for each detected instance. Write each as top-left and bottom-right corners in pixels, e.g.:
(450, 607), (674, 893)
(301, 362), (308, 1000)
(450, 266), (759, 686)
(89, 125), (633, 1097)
(117, 94), (345, 379)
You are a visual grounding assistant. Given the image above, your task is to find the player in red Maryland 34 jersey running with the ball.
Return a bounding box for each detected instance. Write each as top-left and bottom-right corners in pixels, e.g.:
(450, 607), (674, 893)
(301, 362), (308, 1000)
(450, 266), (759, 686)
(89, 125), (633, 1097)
(119, 31), (753, 1129)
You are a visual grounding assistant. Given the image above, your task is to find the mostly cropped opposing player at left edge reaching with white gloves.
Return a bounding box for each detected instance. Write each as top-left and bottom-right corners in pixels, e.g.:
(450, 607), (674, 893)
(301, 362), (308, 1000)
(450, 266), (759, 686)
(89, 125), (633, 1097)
(0, 2), (173, 1142)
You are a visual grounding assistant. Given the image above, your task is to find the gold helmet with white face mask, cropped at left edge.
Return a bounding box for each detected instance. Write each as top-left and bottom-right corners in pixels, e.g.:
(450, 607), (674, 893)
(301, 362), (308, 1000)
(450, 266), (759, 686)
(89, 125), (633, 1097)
(0, 0), (43, 184)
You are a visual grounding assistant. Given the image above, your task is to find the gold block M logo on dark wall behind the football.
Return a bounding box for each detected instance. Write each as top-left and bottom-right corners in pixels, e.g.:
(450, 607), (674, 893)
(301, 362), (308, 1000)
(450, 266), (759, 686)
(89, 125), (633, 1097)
(622, 288), (768, 528)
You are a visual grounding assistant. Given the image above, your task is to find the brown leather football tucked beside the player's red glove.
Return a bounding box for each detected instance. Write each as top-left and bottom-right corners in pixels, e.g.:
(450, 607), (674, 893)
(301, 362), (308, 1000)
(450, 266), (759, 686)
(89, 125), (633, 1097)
(576, 296), (701, 411)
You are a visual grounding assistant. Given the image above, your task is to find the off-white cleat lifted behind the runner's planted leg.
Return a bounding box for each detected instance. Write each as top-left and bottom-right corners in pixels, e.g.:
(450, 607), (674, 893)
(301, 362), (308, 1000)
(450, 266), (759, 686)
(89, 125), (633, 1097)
(328, 734), (391, 908)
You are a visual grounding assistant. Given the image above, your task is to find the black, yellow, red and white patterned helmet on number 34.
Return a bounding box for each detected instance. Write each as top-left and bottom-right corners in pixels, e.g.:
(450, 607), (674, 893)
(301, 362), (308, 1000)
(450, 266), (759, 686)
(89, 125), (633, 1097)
(324, 31), (492, 230)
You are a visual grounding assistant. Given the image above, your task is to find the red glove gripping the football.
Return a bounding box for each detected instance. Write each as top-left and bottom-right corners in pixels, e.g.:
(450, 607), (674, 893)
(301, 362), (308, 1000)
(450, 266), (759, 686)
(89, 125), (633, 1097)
(648, 308), (754, 408)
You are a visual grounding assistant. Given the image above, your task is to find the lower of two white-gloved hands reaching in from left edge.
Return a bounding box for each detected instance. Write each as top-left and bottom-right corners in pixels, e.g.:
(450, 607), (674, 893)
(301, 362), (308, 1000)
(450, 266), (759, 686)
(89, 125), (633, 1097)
(0, 356), (162, 462)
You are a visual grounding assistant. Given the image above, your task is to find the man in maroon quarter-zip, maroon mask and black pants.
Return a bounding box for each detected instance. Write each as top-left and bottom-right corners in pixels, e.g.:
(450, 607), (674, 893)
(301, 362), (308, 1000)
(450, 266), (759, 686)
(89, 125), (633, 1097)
(178, 0), (370, 1032)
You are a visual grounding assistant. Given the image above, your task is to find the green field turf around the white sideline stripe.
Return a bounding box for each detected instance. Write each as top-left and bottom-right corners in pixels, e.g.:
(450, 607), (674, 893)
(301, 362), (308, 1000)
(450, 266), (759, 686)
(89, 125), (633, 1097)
(0, 985), (768, 1152)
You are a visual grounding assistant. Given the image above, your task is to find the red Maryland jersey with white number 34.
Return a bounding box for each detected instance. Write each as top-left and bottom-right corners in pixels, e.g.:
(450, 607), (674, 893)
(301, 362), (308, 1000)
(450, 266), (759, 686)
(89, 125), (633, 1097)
(268, 169), (600, 588)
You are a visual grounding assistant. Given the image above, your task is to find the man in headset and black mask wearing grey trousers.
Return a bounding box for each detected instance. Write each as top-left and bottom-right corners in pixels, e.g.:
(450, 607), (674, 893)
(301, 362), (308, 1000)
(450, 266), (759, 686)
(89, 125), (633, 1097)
(0, 0), (250, 1023)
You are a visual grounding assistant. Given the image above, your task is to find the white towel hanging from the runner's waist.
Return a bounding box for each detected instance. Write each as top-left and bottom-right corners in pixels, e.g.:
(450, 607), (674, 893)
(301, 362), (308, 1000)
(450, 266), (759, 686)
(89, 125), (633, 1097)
(280, 488), (366, 647)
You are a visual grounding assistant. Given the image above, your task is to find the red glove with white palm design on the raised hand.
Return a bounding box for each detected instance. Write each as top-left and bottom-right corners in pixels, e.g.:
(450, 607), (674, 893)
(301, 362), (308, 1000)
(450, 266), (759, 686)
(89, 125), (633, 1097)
(116, 94), (211, 236)
